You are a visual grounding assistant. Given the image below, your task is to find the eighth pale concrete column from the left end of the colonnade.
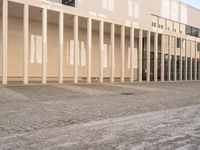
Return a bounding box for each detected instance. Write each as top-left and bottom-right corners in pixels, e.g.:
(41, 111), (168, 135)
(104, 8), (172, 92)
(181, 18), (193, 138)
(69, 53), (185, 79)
(110, 23), (115, 83)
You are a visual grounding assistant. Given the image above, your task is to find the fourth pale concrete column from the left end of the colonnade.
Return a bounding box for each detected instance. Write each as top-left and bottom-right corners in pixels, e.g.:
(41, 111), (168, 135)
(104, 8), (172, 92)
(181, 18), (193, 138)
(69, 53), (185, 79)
(59, 12), (64, 83)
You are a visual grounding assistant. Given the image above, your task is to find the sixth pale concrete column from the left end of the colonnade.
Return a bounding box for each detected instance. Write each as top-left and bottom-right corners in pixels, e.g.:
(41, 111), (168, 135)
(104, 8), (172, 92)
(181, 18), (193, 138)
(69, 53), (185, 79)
(87, 18), (92, 83)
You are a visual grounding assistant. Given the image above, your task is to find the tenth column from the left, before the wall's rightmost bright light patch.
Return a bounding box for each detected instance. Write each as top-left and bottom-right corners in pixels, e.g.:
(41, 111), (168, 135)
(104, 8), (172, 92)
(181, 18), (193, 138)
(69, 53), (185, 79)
(130, 27), (134, 82)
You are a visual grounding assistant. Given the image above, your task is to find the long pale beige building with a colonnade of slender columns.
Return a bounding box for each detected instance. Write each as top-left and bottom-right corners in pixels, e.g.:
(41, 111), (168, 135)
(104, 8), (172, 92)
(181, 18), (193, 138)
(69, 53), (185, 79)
(0, 0), (200, 84)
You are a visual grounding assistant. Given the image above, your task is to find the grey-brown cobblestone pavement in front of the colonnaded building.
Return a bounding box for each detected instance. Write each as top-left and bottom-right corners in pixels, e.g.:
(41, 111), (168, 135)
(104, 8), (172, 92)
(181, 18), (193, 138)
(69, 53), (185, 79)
(0, 82), (200, 150)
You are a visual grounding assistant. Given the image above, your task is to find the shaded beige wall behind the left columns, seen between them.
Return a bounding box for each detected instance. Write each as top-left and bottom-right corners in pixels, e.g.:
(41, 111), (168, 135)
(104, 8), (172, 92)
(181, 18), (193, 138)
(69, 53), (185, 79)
(0, 17), (139, 81)
